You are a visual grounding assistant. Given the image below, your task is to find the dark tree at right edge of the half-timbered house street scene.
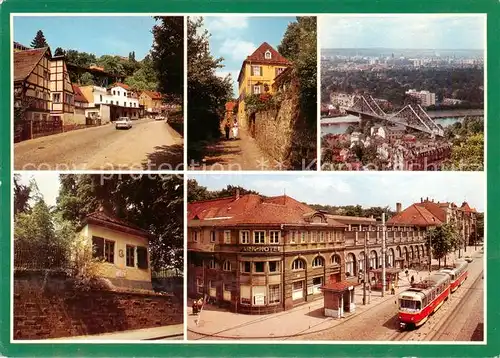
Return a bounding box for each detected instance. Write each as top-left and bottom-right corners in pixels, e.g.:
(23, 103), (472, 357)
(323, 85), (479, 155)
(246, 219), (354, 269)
(151, 16), (184, 103)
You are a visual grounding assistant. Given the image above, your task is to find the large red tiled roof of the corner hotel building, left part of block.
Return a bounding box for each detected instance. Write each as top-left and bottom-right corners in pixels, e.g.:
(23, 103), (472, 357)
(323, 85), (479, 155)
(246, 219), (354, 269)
(188, 194), (345, 227)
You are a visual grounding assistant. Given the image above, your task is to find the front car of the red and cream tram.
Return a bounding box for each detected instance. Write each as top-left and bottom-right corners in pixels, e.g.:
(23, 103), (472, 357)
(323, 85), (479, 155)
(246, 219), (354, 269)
(398, 272), (451, 328)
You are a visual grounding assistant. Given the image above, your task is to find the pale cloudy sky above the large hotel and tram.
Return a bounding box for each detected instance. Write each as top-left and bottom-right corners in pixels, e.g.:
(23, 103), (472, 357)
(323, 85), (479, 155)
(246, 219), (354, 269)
(188, 172), (485, 211)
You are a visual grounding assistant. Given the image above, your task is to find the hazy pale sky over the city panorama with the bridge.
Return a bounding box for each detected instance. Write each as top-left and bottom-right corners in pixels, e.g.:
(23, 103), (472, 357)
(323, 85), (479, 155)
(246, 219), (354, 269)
(318, 14), (486, 50)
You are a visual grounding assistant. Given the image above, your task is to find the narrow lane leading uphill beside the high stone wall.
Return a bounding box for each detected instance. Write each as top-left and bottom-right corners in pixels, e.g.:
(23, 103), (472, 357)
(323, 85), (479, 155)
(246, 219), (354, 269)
(190, 128), (280, 170)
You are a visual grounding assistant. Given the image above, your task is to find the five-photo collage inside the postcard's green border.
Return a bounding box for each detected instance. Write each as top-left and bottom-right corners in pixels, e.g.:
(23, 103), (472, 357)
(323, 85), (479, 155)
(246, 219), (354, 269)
(9, 14), (487, 344)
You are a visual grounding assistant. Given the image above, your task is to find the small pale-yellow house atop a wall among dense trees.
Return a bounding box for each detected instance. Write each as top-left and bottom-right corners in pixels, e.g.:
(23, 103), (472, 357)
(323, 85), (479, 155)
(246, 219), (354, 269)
(80, 211), (152, 290)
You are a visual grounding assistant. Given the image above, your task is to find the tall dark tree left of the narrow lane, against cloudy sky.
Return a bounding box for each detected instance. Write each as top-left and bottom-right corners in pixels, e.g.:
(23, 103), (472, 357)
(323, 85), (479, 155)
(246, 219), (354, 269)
(187, 18), (232, 160)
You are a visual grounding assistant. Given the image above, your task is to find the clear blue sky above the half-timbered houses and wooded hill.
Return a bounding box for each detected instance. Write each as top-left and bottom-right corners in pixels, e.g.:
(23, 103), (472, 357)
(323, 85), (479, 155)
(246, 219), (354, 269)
(14, 16), (155, 60)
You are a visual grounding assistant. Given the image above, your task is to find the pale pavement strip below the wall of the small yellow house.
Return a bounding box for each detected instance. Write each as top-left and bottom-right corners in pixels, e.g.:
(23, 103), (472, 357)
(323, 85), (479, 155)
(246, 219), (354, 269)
(54, 324), (184, 341)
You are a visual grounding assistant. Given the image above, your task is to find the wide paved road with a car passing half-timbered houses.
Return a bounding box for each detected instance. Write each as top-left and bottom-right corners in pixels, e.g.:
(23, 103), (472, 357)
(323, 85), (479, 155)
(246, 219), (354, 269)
(14, 119), (183, 170)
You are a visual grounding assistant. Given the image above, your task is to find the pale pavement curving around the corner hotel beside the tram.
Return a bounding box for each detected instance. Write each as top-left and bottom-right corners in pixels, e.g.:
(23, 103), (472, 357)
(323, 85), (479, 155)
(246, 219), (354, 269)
(186, 248), (480, 339)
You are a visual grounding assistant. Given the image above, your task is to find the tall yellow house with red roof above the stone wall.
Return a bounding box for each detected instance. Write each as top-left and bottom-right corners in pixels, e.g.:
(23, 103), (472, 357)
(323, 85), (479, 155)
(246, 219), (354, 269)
(238, 42), (291, 127)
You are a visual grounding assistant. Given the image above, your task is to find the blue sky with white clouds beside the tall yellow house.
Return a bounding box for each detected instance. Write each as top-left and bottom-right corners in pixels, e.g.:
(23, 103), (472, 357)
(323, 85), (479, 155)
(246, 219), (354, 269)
(200, 16), (296, 98)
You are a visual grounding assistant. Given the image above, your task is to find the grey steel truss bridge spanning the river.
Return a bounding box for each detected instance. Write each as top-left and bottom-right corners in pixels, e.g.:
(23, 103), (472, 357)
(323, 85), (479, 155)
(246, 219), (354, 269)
(347, 96), (444, 137)
